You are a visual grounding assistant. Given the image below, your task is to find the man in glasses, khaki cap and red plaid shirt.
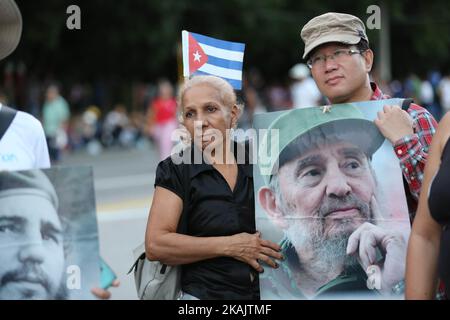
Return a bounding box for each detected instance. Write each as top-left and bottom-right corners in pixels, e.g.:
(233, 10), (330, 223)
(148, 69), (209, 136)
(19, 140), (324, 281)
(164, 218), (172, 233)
(301, 12), (437, 220)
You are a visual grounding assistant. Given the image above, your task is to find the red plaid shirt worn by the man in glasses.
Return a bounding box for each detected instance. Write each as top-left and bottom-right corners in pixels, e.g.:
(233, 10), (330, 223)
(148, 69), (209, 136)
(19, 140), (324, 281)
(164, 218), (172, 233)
(371, 82), (437, 200)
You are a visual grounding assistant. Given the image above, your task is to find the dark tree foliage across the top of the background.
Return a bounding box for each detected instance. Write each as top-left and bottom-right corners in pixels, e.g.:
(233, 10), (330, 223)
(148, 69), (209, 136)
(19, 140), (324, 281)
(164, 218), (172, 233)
(7, 0), (450, 81)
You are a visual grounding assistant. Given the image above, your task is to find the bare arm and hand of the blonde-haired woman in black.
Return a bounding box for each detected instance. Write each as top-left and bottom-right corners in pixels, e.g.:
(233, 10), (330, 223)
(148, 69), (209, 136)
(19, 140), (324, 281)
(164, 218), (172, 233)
(145, 187), (282, 271)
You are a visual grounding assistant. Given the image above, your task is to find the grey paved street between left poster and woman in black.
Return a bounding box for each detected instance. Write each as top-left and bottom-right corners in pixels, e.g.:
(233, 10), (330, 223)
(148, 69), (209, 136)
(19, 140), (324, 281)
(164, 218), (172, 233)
(61, 146), (158, 299)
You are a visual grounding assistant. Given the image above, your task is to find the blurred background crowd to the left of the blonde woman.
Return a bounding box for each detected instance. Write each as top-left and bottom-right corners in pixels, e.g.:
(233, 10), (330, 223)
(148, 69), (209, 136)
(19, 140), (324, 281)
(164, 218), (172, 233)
(0, 80), (177, 163)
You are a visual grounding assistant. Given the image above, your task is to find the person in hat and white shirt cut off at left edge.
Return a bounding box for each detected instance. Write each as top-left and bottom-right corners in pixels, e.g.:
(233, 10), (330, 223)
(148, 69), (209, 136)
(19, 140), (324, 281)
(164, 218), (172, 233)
(0, 0), (119, 299)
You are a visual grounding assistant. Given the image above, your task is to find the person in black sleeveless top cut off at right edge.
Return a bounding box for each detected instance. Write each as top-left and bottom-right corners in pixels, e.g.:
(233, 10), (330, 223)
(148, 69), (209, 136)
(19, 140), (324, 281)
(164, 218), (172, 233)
(406, 113), (450, 299)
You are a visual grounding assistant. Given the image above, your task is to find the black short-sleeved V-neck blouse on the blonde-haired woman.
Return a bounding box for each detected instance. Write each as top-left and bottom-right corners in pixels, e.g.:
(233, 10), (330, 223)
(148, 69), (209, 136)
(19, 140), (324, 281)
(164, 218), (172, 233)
(155, 144), (259, 299)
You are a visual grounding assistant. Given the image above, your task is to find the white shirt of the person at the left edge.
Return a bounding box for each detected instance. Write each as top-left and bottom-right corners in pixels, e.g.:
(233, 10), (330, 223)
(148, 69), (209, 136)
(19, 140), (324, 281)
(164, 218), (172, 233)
(0, 104), (50, 171)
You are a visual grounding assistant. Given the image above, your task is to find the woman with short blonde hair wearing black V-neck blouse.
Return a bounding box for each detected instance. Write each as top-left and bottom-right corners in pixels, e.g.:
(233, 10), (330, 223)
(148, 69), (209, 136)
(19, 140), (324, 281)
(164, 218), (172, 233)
(145, 76), (283, 299)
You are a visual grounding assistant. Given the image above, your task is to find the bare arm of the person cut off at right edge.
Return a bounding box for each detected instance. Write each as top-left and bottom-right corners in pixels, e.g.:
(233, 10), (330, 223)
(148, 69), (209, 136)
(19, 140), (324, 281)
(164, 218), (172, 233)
(405, 113), (450, 299)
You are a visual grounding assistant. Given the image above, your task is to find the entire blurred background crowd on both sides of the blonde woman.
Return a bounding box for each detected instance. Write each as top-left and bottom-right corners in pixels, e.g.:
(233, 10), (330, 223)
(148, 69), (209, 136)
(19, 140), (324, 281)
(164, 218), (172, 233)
(0, 63), (450, 162)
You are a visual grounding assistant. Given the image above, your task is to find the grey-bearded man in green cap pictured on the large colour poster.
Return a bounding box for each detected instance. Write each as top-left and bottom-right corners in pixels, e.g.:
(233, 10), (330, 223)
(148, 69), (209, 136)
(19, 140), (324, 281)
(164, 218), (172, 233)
(258, 105), (406, 299)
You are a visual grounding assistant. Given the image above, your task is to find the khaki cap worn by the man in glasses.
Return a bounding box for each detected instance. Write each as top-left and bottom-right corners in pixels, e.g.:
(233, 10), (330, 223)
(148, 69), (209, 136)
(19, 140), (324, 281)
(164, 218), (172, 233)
(300, 12), (369, 59)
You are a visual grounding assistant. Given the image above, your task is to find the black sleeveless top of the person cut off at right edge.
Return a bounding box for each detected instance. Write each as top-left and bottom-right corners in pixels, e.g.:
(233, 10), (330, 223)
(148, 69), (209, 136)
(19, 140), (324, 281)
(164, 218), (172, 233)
(428, 139), (450, 298)
